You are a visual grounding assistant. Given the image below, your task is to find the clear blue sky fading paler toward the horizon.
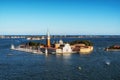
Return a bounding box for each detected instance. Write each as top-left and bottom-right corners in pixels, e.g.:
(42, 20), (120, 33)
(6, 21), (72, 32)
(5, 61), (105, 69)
(0, 0), (120, 35)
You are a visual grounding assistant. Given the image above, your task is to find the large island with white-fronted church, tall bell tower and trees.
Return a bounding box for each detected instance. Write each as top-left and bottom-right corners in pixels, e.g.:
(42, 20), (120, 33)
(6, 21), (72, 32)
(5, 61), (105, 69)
(11, 32), (93, 54)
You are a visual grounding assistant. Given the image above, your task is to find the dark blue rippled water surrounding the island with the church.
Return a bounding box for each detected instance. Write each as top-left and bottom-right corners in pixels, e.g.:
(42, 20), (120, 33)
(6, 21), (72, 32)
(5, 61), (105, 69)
(0, 38), (120, 80)
